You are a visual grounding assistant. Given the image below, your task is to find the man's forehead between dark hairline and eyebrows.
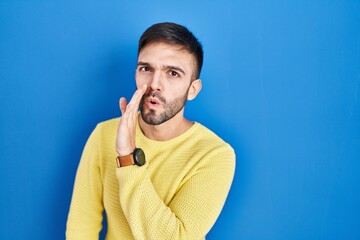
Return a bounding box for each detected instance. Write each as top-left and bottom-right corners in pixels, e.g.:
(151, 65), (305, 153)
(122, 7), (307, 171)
(138, 42), (195, 75)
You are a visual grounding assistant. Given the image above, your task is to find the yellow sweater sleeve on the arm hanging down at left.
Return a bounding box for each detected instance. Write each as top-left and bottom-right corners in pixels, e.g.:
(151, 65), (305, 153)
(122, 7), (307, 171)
(66, 127), (104, 240)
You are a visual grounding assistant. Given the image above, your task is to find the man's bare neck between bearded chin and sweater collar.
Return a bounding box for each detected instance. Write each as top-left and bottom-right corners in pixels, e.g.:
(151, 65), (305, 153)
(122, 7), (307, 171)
(139, 109), (193, 141)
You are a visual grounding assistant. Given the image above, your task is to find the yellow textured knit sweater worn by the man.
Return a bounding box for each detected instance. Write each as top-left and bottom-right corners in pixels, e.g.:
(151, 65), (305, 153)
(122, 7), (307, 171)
(66, 118), (235, 240)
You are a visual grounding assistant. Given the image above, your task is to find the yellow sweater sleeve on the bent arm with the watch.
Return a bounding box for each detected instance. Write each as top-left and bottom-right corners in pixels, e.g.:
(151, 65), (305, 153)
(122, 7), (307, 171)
(116, 146), (235, 240)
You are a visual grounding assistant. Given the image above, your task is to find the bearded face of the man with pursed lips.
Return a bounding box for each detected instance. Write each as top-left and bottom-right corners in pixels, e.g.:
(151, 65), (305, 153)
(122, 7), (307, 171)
(136, 43), (195, 125)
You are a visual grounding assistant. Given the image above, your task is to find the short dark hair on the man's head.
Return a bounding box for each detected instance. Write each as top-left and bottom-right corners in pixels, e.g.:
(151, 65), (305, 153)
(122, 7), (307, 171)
(138, 22), (204, 80)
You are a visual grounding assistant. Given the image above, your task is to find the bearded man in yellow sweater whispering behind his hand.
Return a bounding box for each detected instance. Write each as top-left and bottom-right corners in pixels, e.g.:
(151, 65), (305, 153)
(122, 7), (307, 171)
(66, 23), (235, 240)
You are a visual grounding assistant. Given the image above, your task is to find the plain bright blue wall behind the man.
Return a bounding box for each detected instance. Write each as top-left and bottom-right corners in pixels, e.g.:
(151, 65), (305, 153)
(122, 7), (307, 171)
(0, 0), (360, 240)
